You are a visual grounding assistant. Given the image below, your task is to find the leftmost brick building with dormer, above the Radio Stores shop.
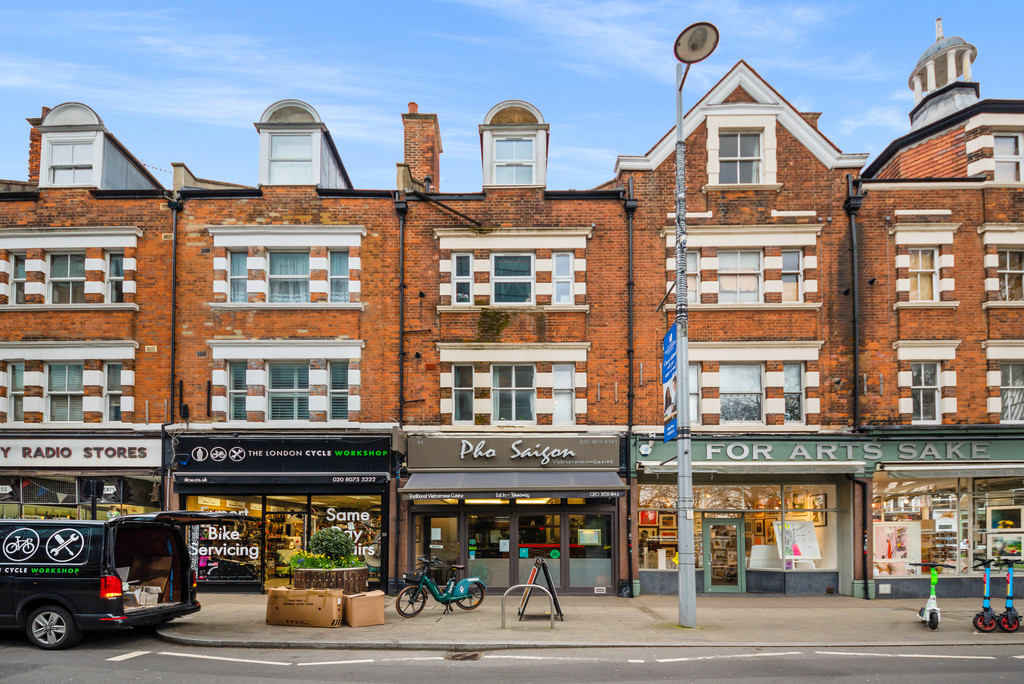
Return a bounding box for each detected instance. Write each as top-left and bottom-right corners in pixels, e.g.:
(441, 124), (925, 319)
(0, 102), (173, 518)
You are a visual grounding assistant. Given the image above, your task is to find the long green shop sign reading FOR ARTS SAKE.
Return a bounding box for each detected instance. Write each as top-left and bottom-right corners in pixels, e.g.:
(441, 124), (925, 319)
(644, 439), (1024, 463)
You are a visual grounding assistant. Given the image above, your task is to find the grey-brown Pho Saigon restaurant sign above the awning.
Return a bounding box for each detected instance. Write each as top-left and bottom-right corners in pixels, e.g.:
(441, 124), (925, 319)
(408, 435), (618, 471)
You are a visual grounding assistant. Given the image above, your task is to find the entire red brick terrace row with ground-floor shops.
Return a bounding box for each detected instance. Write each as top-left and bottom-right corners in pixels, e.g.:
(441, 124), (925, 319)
(0, 21), (1024, 597)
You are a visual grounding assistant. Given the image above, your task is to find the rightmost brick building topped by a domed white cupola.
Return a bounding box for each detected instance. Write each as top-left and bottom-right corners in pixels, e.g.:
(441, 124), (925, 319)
(848, 23), (1024, 597)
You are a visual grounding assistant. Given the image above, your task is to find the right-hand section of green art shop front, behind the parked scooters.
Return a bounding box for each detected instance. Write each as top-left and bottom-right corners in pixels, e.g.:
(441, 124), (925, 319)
(871, 429), (1024, 598)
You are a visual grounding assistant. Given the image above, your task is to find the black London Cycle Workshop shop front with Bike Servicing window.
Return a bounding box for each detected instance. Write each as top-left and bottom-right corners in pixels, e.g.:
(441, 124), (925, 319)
(174, 435), (392, 591)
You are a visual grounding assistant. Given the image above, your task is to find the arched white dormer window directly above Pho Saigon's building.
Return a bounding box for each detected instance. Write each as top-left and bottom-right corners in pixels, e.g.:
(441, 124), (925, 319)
(480, 100), (548, 186)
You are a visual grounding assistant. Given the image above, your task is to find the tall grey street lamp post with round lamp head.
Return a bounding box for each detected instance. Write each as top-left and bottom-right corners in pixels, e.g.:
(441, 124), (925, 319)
(675, 22), (718, 627)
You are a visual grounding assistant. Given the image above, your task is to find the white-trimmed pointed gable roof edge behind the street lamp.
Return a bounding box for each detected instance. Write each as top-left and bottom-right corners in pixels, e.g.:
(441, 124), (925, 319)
(615, 59), (867, 175)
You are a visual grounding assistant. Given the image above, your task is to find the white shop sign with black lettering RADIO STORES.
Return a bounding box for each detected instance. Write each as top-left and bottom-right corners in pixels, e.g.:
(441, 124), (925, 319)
(0, 436), (161, 470)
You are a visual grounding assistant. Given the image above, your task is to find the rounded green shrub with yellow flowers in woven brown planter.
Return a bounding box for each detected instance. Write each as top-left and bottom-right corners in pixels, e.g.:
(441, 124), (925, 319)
(289, 527), (370, 594)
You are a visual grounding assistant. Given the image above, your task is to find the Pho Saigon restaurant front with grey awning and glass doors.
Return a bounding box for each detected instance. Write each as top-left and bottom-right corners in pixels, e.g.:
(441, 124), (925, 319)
(399, 435), (626, 594)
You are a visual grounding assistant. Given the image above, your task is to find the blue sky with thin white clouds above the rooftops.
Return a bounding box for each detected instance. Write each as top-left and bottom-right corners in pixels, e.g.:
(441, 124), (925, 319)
(0, 0), (1024, 191)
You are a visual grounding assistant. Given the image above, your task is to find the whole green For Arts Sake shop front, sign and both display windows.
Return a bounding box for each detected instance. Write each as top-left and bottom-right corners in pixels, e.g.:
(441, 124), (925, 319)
(633, 428), (1024, 599)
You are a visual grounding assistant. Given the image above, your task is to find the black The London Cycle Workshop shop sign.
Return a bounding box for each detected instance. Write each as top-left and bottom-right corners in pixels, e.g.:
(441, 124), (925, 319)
(175, 436), (391, 473)
